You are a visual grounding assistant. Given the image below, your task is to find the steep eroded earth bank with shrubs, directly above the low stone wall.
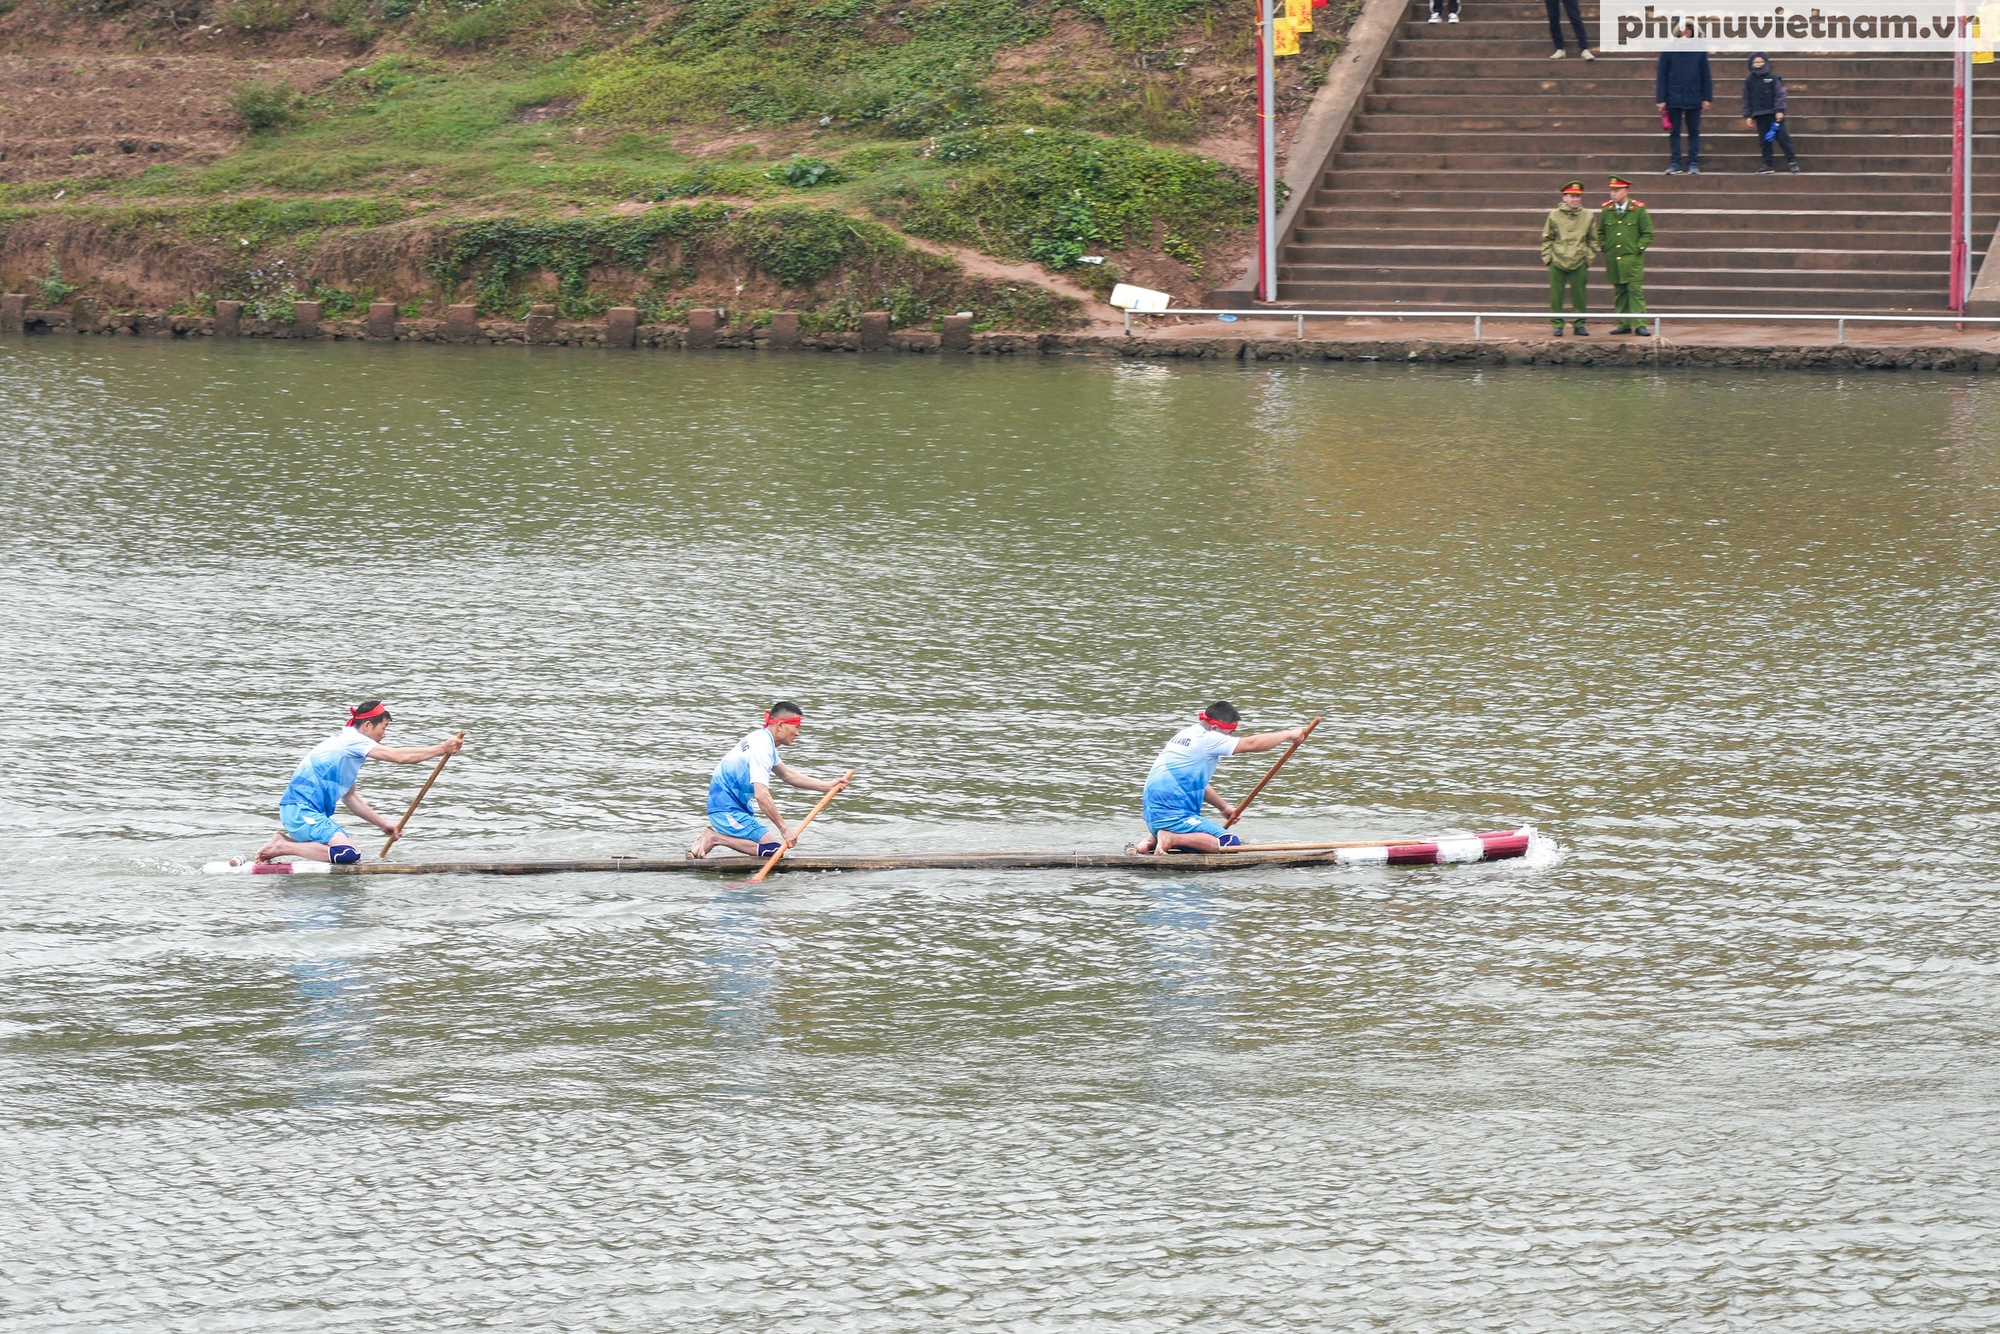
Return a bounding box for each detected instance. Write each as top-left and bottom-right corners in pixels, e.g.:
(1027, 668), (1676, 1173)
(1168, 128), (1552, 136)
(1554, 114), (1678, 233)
(0, 209), (1112, 332)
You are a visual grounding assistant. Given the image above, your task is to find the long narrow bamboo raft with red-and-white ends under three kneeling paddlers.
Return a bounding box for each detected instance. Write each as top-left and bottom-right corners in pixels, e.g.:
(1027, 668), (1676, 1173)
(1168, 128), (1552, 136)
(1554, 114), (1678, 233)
(202, 828), (1532, 876)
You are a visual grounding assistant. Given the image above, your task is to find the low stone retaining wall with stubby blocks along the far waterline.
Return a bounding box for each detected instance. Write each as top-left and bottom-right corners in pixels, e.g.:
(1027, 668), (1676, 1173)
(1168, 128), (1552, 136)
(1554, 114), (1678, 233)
(0, 296), (2000, 374)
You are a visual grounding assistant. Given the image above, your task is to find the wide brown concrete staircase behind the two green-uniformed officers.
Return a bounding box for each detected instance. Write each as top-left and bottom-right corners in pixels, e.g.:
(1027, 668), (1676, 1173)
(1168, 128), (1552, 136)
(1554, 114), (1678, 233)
(1278, 0), (2000, 314)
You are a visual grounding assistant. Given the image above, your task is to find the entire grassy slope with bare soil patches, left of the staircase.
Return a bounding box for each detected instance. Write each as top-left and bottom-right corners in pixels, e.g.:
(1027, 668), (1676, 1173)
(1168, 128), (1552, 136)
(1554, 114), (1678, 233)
(0, 0), (1338, 328)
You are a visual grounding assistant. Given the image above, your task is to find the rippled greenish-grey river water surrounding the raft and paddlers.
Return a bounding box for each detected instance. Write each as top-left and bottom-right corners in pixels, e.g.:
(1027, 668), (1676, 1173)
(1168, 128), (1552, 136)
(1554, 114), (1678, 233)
(0, 338), (2000, 1332)
